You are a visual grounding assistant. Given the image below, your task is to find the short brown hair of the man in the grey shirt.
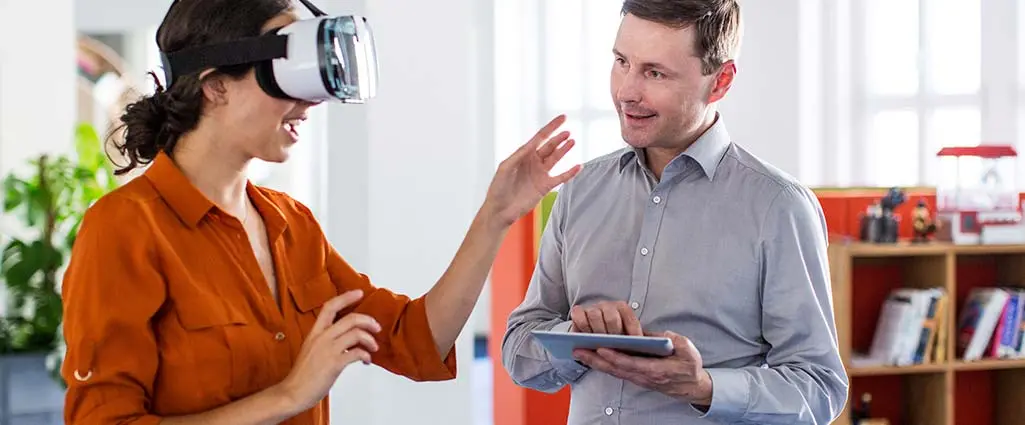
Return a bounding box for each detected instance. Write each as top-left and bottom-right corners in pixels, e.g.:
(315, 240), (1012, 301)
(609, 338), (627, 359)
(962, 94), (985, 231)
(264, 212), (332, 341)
(621, 0), (741, 75)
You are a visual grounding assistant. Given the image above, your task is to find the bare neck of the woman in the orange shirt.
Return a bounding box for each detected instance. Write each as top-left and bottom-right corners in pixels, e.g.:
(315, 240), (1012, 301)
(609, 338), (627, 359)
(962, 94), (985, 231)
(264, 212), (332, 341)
(172, 129), (249, 217)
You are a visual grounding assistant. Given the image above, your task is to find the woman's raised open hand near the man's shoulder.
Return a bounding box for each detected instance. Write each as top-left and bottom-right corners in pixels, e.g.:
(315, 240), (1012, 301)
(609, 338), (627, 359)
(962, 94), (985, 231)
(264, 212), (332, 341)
(484, 115), (580, 226)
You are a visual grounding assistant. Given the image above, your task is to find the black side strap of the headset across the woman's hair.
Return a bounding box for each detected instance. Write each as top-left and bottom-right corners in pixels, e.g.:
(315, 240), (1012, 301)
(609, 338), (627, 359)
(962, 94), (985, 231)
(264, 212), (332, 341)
(161, 33), (288, 86)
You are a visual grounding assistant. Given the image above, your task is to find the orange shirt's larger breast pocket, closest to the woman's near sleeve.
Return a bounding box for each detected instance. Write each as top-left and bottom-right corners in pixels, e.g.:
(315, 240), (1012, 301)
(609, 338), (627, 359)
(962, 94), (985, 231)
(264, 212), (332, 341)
(171, 297), (251, 399)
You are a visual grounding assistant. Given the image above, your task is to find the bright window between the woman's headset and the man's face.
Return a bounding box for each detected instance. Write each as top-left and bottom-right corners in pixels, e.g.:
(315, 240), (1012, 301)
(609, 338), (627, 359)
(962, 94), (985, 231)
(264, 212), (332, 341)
(495, 0), (625, 173)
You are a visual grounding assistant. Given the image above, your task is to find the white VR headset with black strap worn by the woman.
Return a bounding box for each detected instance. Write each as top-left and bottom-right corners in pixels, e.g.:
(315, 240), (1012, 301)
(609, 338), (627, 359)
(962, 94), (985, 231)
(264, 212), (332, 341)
(161, 0), (378, 103)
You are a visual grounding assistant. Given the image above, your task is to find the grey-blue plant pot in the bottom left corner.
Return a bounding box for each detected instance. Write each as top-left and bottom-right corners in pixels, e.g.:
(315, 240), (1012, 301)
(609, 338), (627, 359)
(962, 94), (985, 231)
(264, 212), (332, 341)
(0, 353), (65, 425)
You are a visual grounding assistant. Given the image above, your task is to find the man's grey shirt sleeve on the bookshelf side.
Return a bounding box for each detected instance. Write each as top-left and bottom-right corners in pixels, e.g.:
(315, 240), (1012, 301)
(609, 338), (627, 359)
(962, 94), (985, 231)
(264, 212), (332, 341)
(704, 186), (849, 425)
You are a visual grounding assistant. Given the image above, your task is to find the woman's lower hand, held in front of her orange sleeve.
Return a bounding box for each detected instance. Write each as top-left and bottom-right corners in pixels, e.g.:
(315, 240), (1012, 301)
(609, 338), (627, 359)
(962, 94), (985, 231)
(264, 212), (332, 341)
(278, 291), (380, 414)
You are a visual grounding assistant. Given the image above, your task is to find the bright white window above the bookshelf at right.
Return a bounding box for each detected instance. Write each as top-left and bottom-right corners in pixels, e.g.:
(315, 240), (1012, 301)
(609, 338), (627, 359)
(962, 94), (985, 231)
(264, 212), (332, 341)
(852, 0), (983, 186)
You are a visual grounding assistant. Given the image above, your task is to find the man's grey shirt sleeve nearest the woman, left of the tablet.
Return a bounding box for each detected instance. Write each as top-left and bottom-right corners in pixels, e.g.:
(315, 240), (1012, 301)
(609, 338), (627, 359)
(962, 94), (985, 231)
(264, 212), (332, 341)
(502, 191), (589, 393)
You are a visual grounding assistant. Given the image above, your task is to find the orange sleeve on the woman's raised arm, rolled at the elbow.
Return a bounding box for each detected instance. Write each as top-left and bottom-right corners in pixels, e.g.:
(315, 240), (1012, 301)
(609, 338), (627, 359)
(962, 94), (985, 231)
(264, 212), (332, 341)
(325, 241), (456, 381)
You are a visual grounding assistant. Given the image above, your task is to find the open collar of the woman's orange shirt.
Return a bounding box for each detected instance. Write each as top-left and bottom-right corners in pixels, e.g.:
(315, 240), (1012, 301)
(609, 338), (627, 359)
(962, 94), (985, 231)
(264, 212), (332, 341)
(144, 152), (288, 241)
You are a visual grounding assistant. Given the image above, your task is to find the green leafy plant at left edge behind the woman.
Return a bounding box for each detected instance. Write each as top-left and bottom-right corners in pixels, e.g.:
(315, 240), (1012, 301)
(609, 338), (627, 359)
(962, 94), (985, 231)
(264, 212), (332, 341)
(0, 123), (118, 362)
